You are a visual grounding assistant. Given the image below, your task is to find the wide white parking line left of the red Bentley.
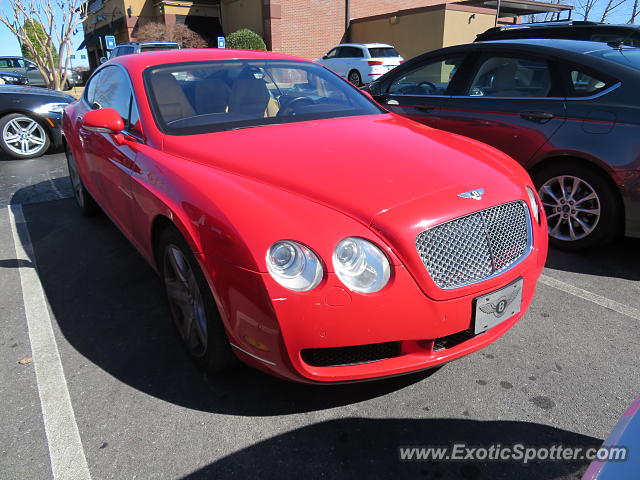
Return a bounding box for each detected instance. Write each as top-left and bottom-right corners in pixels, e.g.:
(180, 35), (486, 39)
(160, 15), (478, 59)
(9, 205), (91, 480)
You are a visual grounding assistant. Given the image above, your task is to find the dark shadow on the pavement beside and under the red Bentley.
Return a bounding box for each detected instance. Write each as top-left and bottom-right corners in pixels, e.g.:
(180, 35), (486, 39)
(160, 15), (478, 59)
(21, 199), (436, 416)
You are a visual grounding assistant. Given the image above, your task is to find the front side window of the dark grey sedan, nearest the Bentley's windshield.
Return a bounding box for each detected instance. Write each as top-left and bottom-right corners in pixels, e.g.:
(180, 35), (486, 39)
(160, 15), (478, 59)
(388, 55), (464, 95)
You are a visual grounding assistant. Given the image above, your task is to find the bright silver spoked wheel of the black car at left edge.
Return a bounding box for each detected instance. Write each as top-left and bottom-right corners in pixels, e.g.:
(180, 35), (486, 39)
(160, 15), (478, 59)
(0, 113), (51, 160)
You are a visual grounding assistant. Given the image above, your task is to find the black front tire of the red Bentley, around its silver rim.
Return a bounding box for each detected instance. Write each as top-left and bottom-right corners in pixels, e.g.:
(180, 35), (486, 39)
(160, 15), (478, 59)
(156, 228), (237, 373)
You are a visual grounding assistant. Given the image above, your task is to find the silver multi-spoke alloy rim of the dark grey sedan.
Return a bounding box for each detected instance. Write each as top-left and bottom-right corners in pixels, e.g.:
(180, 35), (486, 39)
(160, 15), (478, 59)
(538, 175), (600, 241)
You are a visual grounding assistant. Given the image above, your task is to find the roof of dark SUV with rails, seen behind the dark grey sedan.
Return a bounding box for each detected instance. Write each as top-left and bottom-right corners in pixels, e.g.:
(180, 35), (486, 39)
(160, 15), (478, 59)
(476, 21), (640, 47)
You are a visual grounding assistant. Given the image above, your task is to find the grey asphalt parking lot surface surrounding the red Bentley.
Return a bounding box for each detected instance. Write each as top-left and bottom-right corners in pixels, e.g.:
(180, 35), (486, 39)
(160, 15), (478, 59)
(0, 154), (640, 480)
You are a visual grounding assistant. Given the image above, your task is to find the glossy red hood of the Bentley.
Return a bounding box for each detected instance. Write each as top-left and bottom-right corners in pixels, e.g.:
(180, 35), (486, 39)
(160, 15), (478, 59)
(163, 114), (522, 225)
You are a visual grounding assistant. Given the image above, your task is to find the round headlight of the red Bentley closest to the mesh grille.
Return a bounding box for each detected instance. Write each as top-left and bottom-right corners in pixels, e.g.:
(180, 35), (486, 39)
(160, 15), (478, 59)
(333, 237), (391, 293)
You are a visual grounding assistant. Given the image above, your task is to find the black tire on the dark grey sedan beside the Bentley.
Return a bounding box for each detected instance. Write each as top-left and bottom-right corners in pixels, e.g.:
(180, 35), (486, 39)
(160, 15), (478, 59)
(533, 161), (624, 251)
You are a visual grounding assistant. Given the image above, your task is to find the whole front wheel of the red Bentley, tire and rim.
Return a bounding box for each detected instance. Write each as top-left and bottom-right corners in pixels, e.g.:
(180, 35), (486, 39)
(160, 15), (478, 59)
(157, 228), (235, 372)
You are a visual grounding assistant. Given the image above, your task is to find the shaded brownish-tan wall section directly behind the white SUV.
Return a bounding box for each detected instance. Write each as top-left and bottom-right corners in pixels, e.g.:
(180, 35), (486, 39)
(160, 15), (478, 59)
(351, 8), (445, 60)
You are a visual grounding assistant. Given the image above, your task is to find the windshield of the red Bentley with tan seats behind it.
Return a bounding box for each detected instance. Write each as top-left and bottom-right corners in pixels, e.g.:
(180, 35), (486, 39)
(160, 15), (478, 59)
(144, 60), (382, 135)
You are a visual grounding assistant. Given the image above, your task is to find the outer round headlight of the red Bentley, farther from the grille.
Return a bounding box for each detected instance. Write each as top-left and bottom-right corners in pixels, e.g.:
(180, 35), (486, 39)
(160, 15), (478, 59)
(267, 240), (323, 292)
